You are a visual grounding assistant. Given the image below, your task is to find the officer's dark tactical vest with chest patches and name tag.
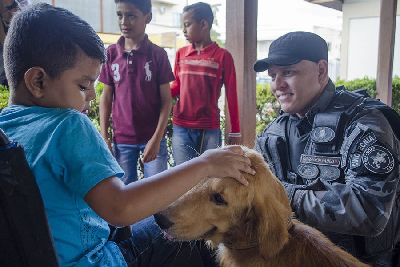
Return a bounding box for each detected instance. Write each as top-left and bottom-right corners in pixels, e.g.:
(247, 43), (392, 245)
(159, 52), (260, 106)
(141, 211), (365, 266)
(257, 87), (400, 262)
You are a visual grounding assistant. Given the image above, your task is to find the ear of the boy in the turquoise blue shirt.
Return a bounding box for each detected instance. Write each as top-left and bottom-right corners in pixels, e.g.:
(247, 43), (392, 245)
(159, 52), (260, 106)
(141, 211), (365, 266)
(24, 67), (47, 99)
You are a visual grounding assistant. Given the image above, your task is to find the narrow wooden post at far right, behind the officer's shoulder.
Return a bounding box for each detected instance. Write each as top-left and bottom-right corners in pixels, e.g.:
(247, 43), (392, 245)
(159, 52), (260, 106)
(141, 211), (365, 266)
(376, 0), (397, 106)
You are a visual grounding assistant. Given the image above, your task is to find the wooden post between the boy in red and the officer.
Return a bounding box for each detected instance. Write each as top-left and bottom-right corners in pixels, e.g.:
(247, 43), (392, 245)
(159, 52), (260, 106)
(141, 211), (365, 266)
(225, 0), (258, 147)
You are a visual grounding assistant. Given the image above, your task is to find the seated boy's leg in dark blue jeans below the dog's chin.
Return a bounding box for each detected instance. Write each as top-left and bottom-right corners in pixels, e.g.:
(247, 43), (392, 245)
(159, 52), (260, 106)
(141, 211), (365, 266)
(118, 217), (217, 267)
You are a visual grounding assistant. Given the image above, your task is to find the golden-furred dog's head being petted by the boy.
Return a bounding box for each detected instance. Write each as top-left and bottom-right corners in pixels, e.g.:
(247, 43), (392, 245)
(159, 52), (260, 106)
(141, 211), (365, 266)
(155, 148), (291, 257)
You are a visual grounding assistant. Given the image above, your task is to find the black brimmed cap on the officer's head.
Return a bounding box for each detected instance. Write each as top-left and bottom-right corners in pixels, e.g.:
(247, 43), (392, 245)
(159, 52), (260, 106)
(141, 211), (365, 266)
(254, 32), (328, 72)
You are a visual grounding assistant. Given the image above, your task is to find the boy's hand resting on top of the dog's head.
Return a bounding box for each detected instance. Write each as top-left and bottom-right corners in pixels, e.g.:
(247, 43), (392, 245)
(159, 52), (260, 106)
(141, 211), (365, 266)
(200, 146), (255, 185)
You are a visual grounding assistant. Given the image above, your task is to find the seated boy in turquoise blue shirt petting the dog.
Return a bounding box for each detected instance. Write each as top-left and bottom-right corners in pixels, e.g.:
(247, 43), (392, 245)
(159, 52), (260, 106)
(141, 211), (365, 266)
(0, 3), (254, 266)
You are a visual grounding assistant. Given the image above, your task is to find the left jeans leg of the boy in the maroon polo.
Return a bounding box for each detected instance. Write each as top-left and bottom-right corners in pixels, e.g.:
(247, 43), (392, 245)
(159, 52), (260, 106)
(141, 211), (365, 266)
(113, 143), (140, 184)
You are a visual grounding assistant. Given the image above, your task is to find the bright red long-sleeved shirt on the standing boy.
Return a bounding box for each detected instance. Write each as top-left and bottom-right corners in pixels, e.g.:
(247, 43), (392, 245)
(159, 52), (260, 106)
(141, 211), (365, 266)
(171, 43), (240, 133)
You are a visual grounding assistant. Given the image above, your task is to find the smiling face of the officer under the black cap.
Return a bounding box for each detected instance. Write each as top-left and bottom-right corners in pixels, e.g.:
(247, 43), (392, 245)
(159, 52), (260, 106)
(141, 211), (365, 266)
(268, 60), (327, 117)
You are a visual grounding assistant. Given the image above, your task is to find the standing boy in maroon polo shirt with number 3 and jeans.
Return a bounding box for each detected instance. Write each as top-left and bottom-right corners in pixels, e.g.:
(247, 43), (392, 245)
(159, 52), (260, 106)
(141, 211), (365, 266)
(99, 0), (174, 184)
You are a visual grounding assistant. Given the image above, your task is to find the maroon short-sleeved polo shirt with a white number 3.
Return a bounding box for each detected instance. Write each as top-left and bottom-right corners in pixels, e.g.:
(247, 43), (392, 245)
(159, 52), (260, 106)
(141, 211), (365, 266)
(99, 36), (174, 144)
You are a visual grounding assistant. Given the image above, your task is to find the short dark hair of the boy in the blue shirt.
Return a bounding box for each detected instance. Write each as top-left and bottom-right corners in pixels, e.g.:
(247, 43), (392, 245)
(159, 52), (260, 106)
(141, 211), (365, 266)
(4, 3), (105, 89)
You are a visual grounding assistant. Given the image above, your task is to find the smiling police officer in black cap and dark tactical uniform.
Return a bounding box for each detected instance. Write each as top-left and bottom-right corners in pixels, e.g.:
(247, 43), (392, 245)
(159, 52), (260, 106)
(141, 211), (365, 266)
(254, 32), (400, 266)
